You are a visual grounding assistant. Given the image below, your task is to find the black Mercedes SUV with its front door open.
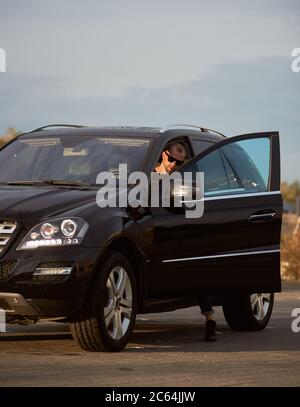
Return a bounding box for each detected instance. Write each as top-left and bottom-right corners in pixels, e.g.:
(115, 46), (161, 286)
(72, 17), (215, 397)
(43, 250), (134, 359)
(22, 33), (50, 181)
(0, 125), (282, 351)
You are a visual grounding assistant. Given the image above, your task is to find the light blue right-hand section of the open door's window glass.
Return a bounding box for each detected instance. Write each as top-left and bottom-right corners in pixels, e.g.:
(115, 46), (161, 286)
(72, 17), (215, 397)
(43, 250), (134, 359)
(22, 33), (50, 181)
(221, 138), (270, 192)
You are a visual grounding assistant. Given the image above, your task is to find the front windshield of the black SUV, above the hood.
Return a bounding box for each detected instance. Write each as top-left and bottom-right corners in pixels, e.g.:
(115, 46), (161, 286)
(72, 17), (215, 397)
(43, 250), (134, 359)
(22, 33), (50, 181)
(0, 134), (150, 185)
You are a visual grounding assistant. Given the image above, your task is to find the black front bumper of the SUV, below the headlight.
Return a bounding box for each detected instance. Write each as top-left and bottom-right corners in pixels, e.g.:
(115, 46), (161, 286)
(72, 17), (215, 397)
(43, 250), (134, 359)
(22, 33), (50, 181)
(0, 247), (101, 318)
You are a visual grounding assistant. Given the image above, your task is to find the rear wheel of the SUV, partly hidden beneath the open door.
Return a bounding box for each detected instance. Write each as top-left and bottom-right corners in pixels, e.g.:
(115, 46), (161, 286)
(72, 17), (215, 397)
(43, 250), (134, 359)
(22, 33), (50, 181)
(223, 293), (274, 331)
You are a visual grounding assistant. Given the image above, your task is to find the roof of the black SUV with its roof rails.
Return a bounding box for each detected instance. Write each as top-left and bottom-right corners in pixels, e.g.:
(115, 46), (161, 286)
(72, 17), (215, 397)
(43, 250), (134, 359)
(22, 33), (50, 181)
(22, 125), (225, 142)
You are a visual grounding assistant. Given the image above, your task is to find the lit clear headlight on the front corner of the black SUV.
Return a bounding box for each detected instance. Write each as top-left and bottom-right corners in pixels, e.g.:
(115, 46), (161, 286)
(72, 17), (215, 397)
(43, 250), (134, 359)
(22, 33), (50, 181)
(17, 218), (89, 250)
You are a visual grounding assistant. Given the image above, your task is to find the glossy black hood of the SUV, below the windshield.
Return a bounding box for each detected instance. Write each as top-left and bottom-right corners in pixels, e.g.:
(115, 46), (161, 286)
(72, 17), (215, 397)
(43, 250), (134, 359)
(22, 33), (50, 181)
(0, 186), (97, 227)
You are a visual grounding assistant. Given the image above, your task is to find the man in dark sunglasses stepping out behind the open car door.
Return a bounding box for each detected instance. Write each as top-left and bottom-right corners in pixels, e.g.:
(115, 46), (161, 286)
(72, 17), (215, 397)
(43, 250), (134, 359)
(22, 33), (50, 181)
(155, 141), (217, 342)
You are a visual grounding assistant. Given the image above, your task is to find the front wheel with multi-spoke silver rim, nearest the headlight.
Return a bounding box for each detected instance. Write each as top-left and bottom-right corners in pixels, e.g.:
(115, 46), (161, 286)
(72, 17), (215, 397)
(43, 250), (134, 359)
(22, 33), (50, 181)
(70, 252), (137, 352)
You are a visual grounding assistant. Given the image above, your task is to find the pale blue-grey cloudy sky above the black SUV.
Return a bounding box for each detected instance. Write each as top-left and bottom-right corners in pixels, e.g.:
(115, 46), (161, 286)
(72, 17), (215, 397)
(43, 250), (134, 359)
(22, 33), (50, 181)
(0, 0), (300, 181)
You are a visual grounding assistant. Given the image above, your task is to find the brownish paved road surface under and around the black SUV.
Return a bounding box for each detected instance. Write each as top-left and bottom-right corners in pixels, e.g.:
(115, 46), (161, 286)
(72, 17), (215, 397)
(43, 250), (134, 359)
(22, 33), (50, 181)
(0, 283), (300, 387)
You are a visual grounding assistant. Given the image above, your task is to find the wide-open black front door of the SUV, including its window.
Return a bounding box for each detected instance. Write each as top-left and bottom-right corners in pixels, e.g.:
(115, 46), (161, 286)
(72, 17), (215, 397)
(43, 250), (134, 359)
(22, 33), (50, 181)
(158, 132), (282, 296)
